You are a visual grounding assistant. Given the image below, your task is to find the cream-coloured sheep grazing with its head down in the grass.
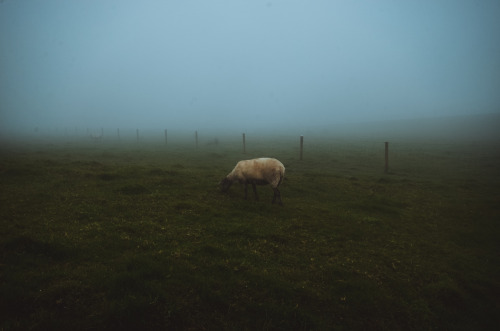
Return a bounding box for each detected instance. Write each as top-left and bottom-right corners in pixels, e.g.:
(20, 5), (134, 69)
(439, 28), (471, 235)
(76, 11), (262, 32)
(219, 157), (285, 205)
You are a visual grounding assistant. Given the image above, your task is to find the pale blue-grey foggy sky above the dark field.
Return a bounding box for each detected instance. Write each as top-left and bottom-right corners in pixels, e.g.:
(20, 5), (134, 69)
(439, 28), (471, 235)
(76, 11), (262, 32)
(0, 0), (500, 131)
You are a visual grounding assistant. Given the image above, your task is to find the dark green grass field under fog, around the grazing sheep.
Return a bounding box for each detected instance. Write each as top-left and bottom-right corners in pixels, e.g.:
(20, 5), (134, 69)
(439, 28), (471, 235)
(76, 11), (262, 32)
(0, 136), (500, 330)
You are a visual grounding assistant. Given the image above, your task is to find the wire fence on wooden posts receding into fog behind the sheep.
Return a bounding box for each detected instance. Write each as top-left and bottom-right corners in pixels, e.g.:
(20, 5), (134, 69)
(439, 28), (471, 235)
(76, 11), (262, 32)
(2, 128), (500, 180)
